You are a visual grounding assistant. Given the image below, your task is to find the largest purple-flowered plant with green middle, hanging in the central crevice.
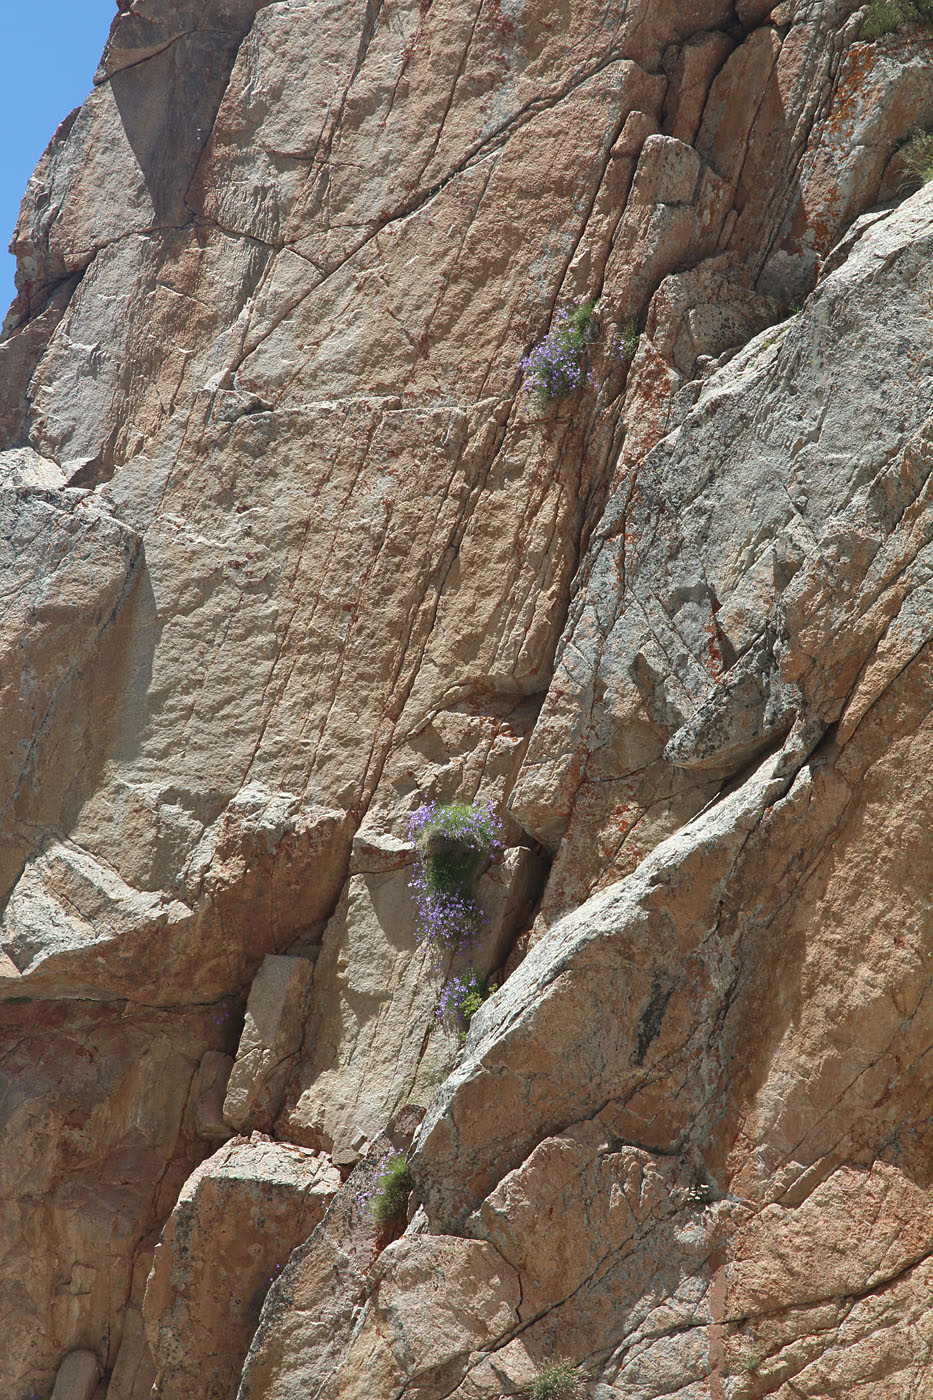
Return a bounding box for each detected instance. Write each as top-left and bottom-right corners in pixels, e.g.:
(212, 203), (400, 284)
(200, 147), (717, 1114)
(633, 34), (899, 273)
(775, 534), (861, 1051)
(408, 802), (502, 955)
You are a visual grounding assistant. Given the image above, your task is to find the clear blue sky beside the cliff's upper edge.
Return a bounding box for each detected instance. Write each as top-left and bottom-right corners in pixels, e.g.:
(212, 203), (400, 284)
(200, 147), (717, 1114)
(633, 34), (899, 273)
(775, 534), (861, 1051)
(0, 0), (116, 322)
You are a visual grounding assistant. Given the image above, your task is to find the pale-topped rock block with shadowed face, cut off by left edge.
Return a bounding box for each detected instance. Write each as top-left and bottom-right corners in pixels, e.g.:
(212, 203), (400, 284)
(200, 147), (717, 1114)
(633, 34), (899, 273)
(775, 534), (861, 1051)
(0, 478), (143, 902)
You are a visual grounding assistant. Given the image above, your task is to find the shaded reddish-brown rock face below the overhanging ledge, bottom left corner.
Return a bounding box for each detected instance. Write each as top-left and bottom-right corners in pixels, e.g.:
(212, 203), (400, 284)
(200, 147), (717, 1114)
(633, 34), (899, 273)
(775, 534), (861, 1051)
(0, 1001), (224, 1400)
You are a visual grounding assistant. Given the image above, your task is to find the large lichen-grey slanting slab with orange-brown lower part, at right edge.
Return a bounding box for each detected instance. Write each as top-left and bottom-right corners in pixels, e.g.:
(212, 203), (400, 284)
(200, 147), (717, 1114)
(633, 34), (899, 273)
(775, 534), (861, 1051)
(510, 186), (933, 927)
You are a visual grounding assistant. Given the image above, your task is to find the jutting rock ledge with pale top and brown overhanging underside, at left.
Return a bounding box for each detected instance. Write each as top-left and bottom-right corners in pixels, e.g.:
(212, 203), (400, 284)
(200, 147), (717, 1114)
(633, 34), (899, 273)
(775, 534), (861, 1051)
(0, 783), (346, 1002)
